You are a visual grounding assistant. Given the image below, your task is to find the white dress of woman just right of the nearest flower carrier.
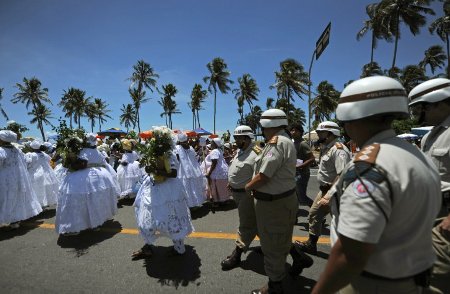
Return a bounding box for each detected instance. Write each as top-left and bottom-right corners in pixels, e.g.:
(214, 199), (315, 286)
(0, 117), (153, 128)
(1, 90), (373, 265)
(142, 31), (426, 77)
(175, 145), (206, 207)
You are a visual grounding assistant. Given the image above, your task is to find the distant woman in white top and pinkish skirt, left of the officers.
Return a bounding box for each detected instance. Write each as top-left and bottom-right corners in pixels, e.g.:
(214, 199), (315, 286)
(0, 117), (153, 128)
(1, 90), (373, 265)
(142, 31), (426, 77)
(205, 138), (230, 207)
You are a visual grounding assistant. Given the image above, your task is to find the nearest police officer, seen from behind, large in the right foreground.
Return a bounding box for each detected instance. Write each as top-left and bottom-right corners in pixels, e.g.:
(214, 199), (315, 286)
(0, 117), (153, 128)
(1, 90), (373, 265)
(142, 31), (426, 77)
(312, 76), (441, 293)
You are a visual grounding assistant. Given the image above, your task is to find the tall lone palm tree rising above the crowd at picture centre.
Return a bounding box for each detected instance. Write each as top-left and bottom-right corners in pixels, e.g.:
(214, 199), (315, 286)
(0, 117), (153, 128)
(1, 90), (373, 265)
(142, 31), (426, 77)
(203, 57), (233, 134)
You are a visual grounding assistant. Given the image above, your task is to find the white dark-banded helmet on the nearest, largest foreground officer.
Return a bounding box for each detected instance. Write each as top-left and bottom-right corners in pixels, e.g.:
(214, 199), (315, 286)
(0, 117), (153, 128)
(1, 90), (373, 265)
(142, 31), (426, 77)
(336, 76), (409, 121)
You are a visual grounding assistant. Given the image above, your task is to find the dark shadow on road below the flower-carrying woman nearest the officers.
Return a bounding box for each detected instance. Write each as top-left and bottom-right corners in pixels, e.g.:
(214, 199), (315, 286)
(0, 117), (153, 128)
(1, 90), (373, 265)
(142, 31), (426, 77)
(144, 245), (202, 289)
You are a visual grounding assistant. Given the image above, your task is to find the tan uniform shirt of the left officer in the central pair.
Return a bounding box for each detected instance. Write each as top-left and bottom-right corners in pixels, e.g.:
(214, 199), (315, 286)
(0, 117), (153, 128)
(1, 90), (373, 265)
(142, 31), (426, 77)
(228, 143), (261, 189)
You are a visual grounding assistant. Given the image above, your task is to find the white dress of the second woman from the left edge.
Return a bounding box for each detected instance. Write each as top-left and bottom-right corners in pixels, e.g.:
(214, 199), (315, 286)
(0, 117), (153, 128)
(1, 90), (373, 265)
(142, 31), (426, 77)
(25, 152), (59, 207)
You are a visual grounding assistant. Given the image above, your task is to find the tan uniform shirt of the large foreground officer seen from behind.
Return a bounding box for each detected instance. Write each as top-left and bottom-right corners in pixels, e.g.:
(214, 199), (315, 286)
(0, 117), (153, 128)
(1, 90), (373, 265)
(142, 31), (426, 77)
(331, 130), (441, 279)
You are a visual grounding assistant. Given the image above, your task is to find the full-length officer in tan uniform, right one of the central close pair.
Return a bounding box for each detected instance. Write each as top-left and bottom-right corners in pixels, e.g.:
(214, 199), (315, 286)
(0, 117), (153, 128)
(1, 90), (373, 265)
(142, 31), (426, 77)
(245, 109), (312, 293)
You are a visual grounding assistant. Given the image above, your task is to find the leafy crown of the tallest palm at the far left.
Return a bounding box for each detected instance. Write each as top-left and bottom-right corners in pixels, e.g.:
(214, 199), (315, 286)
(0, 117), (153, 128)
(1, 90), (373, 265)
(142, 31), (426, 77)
(11, 77), (52, 109)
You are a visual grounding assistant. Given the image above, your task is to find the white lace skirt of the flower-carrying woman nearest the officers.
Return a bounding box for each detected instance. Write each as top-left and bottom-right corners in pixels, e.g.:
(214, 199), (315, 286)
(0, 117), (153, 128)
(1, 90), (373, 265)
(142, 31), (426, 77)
(134, 156), (194, 244)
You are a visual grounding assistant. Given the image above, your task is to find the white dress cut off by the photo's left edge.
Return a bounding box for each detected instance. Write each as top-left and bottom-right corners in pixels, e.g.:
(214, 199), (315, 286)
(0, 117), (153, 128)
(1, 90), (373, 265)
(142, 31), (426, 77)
(0, 147), (42, 224)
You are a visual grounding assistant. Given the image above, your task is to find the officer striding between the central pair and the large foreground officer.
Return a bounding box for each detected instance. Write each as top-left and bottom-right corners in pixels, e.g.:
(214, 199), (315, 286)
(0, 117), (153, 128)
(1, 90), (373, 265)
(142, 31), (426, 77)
(295, 121), (351, 255)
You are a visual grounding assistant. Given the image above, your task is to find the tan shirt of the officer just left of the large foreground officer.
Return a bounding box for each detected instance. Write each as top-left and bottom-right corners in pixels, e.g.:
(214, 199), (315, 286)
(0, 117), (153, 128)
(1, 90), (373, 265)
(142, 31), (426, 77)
(317, 139), (351, 185)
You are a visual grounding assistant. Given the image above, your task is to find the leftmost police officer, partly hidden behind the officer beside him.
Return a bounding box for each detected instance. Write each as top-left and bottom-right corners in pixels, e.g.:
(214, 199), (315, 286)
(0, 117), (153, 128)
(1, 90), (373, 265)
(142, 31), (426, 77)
(221, 126), (262, 270)
